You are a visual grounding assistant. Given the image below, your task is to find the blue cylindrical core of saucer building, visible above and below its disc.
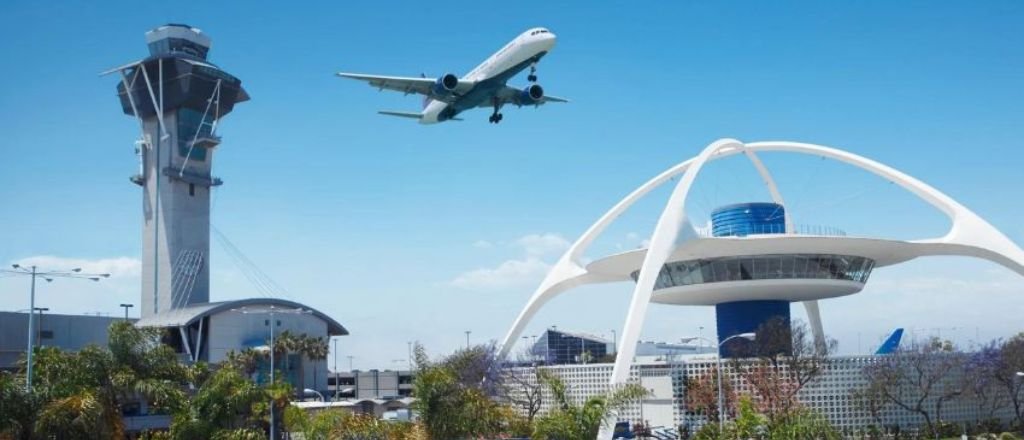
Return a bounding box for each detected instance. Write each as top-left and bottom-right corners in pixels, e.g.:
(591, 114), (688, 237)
(711, 203), (792, 357)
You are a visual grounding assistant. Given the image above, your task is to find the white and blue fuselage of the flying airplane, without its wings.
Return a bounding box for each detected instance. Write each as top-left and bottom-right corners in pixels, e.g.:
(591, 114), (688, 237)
(420, 28), (555, 124)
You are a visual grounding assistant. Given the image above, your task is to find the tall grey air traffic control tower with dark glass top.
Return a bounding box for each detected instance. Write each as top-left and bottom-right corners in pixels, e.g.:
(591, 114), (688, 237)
(108, 25), (249, 318)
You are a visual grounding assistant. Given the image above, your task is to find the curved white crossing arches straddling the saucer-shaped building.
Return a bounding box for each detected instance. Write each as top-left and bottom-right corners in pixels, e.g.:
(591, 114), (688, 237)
(500, 139), (1024, 376)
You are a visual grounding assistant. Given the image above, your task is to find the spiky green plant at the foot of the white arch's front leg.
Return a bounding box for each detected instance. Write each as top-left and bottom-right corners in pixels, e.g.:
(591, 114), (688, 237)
(531, 372), (647, 440)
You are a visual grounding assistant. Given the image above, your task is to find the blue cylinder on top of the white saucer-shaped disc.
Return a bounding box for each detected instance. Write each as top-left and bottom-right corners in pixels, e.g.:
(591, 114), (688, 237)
(711, 203), (785, 236)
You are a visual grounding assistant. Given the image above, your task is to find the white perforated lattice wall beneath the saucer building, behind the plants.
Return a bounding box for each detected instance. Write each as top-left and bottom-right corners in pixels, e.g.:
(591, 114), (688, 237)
(508, 354), (1014, 436)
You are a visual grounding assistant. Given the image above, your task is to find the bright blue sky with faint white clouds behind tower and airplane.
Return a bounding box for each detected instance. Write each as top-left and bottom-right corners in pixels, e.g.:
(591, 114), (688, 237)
(0, 1), (1024, 368)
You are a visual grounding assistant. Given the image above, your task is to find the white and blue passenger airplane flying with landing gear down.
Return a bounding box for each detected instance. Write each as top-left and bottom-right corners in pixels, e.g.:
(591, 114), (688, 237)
(337, 28), (568, 124)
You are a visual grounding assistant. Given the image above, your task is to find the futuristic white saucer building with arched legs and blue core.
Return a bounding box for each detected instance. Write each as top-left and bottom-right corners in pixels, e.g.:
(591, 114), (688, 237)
(500, 139), (1024, 433)
